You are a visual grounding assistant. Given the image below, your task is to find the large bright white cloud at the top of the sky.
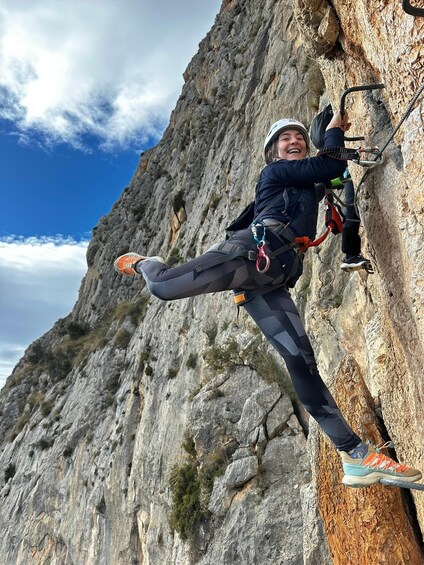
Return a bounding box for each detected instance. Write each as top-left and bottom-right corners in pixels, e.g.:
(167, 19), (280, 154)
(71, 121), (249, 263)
(0, 0), (220, 150)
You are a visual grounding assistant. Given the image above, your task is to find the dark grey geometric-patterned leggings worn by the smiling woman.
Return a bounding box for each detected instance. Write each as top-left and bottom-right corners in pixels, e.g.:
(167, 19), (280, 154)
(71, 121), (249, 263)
(137, 240), (361, 451)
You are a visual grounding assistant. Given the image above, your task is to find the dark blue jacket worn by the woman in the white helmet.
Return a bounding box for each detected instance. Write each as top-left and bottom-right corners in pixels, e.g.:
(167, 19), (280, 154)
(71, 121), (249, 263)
(255, 128), (346, 239)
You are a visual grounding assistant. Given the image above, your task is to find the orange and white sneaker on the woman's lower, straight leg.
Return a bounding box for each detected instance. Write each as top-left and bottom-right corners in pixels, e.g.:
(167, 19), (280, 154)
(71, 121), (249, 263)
(339, 442), (422, 487)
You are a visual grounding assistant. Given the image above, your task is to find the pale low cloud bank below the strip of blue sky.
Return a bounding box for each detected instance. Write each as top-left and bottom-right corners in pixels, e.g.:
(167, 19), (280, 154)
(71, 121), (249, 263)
(0, 236), (88, 387)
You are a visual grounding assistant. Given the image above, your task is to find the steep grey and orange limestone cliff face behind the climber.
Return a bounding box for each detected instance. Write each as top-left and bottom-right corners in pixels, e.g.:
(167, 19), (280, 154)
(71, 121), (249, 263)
(0, 0), (424, 565)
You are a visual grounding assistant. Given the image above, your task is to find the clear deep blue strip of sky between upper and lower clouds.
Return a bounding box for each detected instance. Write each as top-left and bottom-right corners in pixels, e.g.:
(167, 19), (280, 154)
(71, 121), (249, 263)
(0, 131), (139, 241)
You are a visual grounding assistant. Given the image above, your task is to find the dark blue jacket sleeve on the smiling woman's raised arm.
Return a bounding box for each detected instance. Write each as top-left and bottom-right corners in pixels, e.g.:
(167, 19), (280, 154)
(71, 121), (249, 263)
(271, 128), (347, 187)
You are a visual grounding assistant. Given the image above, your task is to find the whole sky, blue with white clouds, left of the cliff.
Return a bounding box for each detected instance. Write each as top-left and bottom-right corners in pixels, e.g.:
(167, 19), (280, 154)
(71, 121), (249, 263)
(0, 0), (221, 386)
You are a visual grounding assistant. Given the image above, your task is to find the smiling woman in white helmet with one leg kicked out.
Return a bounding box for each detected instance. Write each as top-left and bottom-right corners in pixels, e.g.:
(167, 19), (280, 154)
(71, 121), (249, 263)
(115, 113), (421, 487)
